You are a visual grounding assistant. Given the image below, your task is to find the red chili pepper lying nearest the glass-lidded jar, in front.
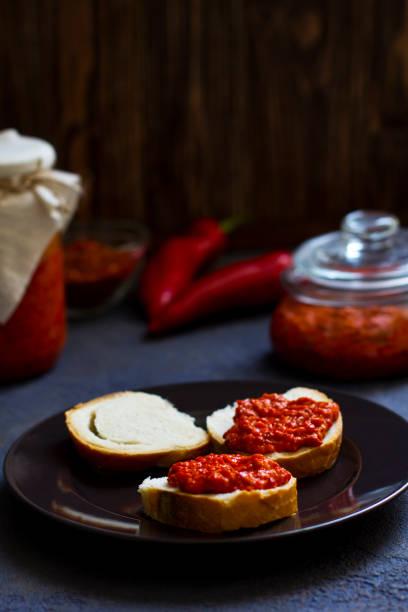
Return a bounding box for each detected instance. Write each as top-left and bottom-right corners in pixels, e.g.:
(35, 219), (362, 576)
(149, 251), (292, 334)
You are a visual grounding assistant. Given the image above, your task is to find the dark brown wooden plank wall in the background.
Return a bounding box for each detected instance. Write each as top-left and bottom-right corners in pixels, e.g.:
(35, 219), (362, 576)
(0, 0), (408, 247)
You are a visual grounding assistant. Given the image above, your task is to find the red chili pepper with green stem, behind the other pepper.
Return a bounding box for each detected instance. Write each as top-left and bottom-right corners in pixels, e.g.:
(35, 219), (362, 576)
(139, 217), (237, 318)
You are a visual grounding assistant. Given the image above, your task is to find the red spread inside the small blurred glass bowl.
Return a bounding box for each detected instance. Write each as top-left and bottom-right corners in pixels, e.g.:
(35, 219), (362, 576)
(65, 238), (144, 308)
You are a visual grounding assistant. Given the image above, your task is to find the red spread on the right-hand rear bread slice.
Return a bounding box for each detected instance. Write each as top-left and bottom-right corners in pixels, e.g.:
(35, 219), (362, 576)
(224, 393), (339, 454)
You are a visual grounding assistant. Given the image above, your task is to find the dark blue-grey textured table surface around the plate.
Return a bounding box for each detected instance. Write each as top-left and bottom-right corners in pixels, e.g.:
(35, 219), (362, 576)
(0, 305), (408, 612)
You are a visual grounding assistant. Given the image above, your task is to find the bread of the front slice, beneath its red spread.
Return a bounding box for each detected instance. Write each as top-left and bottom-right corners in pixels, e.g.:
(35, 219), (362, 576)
(139, 476), (297, 533)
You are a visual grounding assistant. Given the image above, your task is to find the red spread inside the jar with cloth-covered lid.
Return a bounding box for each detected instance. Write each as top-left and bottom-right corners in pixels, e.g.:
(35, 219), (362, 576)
(0, 236), (66, 380)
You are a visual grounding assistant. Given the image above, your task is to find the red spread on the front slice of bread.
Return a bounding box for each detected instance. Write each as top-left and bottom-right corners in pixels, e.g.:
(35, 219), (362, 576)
(167, 453), (291, 493)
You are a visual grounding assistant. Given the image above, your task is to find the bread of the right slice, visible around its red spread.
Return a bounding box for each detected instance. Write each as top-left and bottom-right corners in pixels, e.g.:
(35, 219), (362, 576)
(207, 387), (343, 478)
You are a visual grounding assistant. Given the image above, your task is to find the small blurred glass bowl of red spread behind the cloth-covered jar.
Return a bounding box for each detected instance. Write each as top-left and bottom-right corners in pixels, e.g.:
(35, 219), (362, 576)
(64, 219), (149, 319)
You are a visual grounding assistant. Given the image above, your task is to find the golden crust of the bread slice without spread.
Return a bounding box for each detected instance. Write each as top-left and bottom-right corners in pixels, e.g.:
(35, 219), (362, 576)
(65, 391), (210, 472)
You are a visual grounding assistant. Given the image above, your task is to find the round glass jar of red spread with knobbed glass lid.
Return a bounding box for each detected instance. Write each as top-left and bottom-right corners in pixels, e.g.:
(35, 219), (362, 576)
(271, 210), (408, 379)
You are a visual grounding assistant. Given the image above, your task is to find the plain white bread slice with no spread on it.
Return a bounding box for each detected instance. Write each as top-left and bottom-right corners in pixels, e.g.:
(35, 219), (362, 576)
(65, 391), (209, 471)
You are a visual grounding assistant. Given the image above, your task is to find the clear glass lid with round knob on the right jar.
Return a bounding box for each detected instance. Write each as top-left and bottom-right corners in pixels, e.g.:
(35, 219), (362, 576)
(283, 210), (408, 306)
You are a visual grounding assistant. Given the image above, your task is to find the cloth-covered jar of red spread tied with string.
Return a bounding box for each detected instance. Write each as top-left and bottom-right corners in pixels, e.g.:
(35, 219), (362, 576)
(0, 130), (80, 381)
